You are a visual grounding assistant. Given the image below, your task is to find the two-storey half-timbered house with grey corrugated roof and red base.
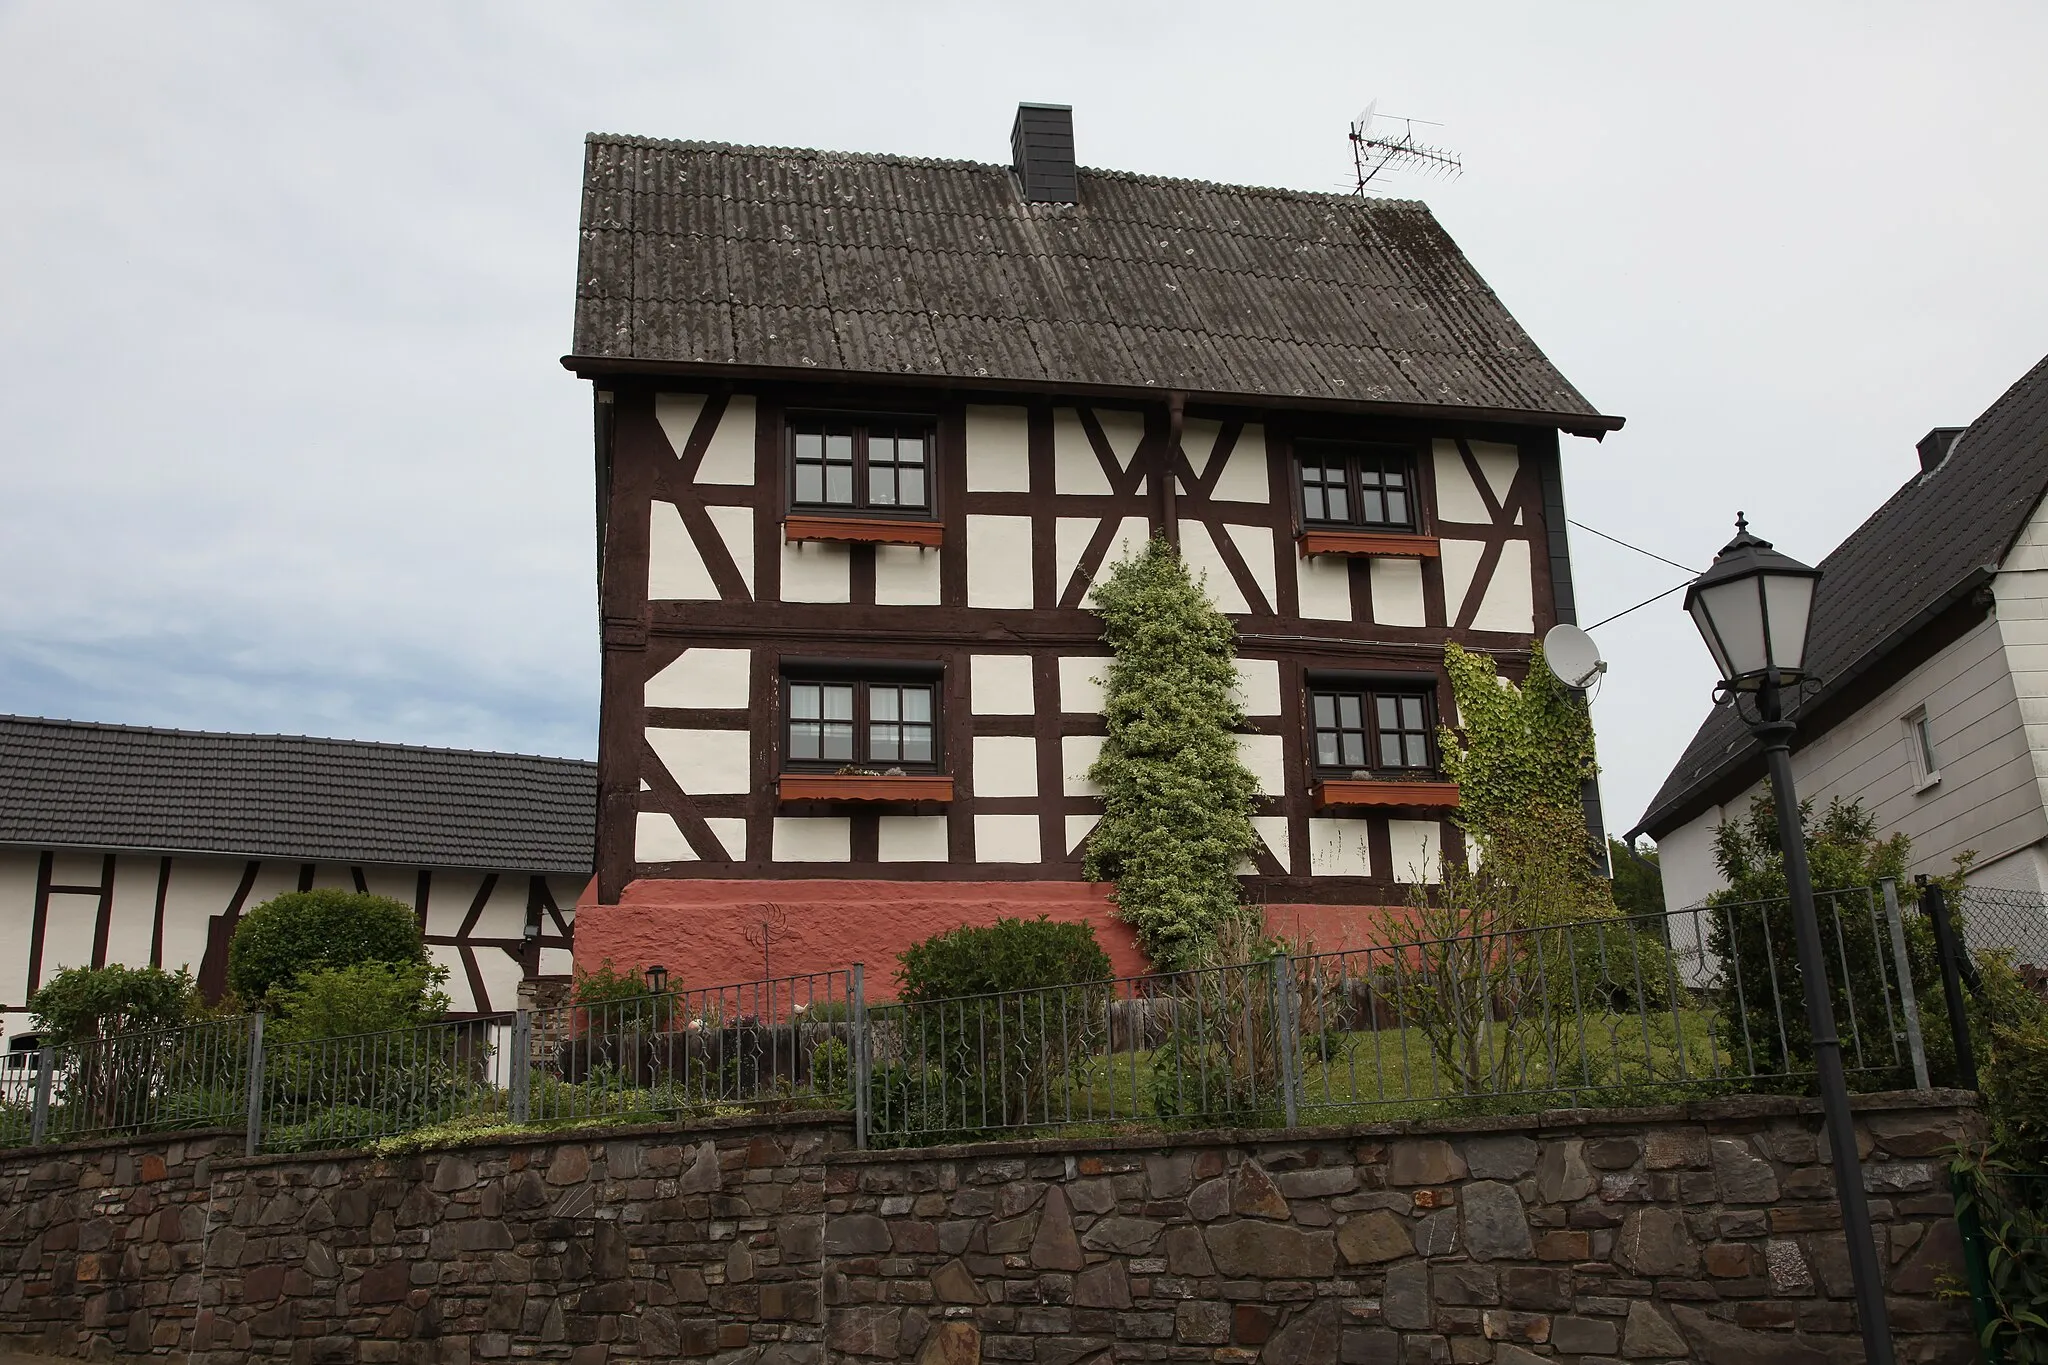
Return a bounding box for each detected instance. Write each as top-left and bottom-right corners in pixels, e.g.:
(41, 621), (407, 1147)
(563, 104), (1620, 982)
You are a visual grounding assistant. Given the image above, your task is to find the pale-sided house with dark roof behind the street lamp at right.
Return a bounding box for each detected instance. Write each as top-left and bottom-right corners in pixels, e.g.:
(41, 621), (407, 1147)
(1630, 360), (2048, 925)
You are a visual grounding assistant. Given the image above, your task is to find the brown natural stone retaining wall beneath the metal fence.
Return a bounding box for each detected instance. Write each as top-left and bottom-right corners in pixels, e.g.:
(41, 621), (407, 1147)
(0, 1093), (1974, 1365)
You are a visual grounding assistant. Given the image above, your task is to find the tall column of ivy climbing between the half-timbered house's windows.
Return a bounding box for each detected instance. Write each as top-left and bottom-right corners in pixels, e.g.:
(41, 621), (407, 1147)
(1085, 538), (1257, 970)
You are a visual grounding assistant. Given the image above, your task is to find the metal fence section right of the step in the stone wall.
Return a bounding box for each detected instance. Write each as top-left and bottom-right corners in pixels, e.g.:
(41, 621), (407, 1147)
(860, 890), (1927, 1146)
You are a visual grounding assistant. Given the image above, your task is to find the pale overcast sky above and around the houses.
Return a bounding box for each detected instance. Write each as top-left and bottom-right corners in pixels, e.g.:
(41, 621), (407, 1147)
(0, 0), (2048, 829)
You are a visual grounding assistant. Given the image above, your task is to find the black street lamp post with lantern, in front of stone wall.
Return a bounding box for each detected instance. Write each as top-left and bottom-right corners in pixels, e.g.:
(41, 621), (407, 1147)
(1686, 514), (1892, 1365)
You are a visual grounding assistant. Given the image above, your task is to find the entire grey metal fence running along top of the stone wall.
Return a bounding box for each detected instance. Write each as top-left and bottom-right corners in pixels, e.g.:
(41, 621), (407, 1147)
(0, 888), (1982, 1152)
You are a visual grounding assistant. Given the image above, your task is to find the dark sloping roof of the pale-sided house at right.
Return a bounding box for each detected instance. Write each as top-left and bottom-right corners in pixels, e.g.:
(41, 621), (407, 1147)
(1630, 358), (2048, 837)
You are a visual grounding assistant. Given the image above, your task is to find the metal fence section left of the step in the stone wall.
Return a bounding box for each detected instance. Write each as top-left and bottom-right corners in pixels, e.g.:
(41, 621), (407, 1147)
(0, 968), (860, 1152)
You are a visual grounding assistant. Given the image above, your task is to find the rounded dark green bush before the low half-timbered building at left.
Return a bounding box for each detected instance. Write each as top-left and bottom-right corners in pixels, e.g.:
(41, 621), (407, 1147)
(227, 890), (428, 1003)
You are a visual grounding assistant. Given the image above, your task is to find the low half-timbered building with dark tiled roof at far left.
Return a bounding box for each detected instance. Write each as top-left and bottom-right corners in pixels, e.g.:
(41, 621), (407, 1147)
(0, 716), (596, 1029)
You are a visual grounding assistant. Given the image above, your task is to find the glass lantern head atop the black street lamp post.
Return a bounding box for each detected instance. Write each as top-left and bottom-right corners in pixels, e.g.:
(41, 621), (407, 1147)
(1686, 512), (1821, 699)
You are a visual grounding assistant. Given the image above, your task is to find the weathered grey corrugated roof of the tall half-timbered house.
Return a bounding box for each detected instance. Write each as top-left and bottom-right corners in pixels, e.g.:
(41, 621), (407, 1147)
(565, 133), (1620, 434)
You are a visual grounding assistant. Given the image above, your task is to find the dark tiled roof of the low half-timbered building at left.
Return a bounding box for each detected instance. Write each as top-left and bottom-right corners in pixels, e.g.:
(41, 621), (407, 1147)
(0, 716), (598, 876)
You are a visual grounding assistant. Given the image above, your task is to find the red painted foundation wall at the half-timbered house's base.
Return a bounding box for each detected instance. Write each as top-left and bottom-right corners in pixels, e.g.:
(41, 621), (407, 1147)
(575, 878), (1409, 999)
